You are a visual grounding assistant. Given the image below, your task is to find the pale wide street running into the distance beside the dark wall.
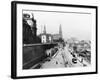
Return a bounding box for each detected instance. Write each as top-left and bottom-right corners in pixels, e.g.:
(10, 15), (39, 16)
(31, 45), (90, 69)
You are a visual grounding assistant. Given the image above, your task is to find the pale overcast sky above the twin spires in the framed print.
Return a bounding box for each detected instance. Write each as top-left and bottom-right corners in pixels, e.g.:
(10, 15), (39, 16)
(24, 11), (92, 40)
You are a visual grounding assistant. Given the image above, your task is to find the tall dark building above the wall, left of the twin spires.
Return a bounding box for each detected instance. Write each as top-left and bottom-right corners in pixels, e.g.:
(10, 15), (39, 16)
(23, 13), (41, 44)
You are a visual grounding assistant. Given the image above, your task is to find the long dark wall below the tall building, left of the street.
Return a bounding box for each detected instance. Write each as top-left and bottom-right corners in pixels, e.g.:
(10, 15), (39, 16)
(23, 44), (57, 69)
